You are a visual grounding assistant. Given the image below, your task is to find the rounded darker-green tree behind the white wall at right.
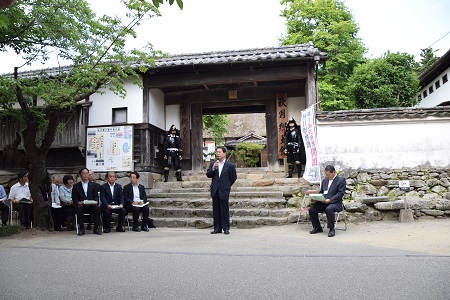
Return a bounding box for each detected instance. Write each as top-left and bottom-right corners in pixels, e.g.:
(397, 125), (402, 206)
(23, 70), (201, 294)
(348, 52), (419, 108)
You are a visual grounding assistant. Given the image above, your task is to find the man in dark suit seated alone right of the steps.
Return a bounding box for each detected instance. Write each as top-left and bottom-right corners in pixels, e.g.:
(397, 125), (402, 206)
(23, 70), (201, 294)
(306, 165), (346, 237)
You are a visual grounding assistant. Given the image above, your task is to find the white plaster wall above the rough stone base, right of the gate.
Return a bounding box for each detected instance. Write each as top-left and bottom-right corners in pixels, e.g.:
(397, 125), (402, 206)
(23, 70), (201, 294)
(317, 118), (450, 169)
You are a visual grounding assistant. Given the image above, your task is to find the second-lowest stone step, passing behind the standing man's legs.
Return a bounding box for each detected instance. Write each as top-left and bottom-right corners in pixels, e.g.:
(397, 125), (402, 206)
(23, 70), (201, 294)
(151, 207), (292, 218)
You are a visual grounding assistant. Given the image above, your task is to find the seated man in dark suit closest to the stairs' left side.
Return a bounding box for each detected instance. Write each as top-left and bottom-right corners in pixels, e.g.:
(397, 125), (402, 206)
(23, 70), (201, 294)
(123, 172), (150, 231)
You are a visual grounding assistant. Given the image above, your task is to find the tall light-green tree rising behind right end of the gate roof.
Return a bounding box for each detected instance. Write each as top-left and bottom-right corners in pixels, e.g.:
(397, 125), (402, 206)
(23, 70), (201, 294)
(280, 0), (365, 110)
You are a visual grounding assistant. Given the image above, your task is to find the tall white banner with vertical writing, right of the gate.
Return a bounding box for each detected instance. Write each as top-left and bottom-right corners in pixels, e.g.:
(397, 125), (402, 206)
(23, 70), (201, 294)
(300, 105), (320, 183)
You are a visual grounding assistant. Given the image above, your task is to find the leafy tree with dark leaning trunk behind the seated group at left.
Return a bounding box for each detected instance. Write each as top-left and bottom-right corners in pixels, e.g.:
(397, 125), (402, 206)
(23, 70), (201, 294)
(0, 0), (182, 228)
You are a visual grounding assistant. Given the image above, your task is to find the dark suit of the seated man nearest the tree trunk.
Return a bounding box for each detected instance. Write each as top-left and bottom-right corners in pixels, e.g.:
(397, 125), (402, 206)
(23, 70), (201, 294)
(72, 181), (100, 229)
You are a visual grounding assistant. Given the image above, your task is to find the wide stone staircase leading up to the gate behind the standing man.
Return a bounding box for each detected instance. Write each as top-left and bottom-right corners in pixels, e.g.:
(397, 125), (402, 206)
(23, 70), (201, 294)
(148, 168), (308, 228)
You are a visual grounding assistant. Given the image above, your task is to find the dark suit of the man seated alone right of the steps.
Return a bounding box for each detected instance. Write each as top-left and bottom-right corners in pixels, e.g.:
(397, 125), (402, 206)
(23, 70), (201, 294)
(309, 175), (346, 229)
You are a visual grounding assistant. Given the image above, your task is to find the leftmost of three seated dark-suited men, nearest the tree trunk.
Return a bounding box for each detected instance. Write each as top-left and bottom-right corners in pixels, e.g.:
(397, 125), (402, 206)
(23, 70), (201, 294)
(72, 168), (102, 236)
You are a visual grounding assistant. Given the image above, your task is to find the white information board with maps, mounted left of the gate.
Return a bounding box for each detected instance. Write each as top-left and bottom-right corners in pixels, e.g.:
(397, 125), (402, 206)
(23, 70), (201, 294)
(86, 125), (133, 171)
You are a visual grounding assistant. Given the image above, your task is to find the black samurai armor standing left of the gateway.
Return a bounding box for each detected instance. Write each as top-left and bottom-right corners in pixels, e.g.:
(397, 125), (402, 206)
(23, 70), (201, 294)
(164, 125), (183, 182)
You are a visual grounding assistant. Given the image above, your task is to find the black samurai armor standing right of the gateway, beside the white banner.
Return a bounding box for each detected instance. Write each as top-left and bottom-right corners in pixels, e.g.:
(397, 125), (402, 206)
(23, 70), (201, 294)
(284, 118), (302, 178)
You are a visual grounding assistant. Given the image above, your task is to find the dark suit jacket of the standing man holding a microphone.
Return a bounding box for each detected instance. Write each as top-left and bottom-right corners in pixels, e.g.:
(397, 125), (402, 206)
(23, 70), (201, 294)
(206, 161), (237, 200)
